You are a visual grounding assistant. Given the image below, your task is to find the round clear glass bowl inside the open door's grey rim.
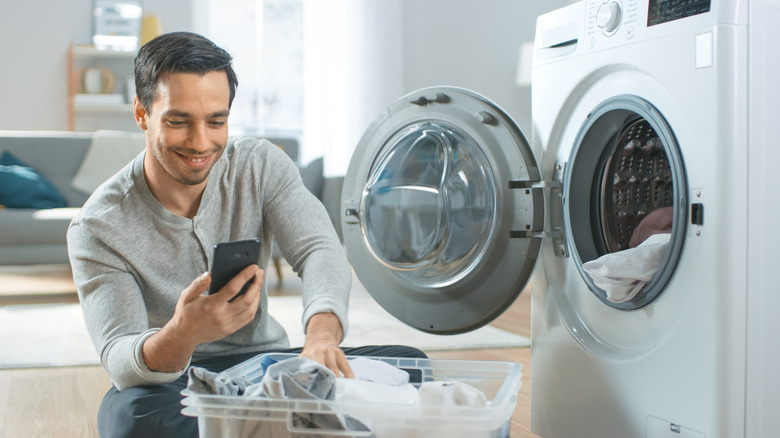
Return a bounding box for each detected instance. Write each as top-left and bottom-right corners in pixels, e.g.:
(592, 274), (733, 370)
(360, 121), (496, 288)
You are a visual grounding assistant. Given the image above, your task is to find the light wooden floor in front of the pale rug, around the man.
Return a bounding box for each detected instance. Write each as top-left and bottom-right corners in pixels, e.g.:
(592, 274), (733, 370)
(0, 266), (537, 438)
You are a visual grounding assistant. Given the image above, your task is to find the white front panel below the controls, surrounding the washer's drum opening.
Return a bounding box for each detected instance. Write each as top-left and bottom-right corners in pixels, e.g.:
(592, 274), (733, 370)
(531, 17), (746, 438)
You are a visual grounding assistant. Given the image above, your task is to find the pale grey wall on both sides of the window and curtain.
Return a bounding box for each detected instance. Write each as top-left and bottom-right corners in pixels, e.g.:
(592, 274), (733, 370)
(0, 0), (573, 149)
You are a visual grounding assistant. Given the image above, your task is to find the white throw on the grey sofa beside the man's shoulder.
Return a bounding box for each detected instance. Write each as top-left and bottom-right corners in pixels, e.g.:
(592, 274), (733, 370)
(72, 131), (146, 194)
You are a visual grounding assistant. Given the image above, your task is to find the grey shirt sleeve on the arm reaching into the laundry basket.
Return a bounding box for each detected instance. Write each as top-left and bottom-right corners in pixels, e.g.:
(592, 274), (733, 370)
(263, 144), (352, 340)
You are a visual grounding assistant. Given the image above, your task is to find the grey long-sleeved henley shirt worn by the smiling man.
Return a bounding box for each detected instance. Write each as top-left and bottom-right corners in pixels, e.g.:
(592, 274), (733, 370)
(68, 138), (352, 390)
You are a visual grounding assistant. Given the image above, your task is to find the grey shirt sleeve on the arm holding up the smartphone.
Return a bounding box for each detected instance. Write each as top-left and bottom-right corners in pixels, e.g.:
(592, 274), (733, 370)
(68, 221), (187, 391)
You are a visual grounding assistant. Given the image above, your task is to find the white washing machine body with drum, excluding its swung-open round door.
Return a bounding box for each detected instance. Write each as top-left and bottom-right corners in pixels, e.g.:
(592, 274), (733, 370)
(531, 0), (780, 438)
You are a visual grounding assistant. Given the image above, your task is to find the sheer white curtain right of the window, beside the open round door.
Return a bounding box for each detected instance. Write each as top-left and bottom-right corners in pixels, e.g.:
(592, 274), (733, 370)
(301, 0), (403, 176)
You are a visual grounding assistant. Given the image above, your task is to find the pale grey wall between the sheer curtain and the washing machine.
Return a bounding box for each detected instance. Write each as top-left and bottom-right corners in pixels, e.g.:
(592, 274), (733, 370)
(403, 0), (575, 137)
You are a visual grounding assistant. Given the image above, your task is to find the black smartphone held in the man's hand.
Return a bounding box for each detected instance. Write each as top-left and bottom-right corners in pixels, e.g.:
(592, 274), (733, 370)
(209, 239), (260, 301)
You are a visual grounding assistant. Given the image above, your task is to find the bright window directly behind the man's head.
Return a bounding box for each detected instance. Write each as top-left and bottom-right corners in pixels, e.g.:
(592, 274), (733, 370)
(196, 0), (303, 137)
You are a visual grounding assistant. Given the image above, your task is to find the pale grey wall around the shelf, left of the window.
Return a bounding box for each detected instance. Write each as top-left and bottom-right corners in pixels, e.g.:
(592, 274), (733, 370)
(0, 0), (192, 130)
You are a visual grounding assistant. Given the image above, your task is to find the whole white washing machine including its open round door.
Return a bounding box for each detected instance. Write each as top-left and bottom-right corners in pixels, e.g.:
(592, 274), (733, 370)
(340, 0), (780, 438)
